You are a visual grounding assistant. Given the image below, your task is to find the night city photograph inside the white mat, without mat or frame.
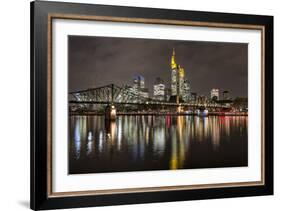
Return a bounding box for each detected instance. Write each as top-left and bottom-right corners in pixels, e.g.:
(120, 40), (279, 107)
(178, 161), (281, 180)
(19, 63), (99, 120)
(68, 36), (248, 174)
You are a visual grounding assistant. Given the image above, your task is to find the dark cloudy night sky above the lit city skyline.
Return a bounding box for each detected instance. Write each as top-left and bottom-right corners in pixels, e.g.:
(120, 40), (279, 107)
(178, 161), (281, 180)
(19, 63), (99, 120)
(68, 36), (248, 98)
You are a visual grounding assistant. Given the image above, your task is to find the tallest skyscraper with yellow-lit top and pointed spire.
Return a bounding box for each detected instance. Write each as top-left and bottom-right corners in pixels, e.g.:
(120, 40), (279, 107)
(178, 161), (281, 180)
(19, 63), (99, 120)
(168, 49), (190, 101)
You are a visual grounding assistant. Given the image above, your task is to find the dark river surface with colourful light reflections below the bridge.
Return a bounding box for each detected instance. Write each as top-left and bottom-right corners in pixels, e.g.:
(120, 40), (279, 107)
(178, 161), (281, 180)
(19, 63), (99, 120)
(69, 116), (248, 174)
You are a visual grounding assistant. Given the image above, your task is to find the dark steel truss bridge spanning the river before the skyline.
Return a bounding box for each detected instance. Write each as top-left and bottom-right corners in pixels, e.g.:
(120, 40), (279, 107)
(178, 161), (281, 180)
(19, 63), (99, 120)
(68, 84), (229, 109)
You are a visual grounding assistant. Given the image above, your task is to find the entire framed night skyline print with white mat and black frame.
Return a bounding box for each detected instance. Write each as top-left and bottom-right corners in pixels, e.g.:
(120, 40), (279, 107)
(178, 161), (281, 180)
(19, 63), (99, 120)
(31, 1), (273, 210)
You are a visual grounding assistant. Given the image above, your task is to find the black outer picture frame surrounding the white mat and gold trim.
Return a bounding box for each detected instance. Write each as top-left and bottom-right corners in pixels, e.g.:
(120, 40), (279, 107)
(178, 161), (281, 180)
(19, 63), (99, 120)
(30, 1), (273, 210)
